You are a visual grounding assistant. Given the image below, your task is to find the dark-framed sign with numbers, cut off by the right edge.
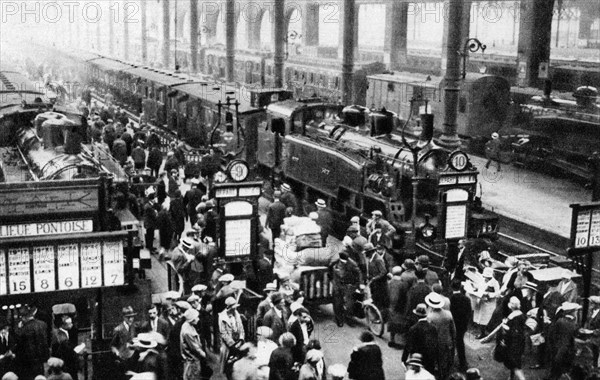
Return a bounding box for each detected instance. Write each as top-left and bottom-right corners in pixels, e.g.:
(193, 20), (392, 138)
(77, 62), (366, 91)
(571, 202), (600, 253)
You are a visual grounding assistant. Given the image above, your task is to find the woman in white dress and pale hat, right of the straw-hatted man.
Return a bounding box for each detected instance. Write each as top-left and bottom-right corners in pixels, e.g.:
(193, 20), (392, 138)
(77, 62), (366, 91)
(465, 267), (500, 339)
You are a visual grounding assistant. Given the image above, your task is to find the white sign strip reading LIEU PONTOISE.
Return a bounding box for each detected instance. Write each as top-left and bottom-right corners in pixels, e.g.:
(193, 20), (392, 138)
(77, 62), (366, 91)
(0, 220), (94, 238)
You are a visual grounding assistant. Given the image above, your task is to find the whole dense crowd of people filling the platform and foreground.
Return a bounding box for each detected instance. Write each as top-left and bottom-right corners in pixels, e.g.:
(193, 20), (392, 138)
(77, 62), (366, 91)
(0, 92), (600, 380)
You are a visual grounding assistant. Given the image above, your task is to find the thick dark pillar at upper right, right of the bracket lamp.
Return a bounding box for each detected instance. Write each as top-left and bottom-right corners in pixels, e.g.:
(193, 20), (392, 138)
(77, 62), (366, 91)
(517, 0), (554, 87)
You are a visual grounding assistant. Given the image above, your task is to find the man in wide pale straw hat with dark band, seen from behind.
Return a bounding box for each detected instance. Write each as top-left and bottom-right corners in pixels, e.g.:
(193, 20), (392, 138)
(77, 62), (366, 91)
(425, 292), (456, 379)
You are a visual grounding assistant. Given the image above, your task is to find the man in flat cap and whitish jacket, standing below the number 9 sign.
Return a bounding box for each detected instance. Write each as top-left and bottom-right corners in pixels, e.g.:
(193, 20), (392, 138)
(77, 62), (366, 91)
(219, 297), (246, 374)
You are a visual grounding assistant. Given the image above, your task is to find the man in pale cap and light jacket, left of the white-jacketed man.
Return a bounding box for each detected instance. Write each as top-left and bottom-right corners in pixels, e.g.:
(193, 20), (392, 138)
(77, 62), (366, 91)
(180, 308), (206, 380)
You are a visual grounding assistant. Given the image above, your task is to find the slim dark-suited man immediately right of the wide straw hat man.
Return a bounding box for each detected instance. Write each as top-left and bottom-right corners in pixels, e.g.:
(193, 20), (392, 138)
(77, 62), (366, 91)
(450, 281), (473, 372)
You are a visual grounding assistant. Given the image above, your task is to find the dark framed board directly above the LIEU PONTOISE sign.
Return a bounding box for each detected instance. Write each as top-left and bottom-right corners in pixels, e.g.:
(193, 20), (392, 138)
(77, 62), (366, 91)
(0, 187), (98, 217)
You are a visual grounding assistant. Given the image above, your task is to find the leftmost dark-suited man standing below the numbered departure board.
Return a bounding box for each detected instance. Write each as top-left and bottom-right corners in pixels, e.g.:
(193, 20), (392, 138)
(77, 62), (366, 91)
(15, 305), (50, 379)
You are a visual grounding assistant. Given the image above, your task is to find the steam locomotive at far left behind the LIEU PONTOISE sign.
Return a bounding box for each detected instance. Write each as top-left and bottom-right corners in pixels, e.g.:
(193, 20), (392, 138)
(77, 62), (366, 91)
(0, 66), (127, 182)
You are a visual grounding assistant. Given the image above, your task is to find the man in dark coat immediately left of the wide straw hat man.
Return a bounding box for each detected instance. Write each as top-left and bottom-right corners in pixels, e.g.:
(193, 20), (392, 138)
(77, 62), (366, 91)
(402, 303), (438, 372)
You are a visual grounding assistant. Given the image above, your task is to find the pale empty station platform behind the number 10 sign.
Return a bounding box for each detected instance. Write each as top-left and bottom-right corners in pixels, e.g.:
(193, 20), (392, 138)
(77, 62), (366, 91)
(471, 156), (592, 238)
